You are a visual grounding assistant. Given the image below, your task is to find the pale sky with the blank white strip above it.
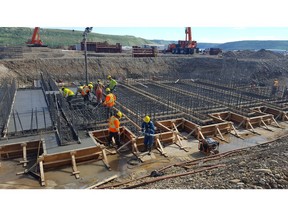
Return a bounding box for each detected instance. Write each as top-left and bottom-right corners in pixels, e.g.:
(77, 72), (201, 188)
(0, 0), (288, 43)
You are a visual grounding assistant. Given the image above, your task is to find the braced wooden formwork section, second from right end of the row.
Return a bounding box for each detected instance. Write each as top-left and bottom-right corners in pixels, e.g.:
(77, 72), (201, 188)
(210, 112), (280, 134)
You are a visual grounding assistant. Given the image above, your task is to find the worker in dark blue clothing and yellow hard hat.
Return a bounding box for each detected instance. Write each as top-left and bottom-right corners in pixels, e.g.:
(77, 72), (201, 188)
(141, 115), (155, 155)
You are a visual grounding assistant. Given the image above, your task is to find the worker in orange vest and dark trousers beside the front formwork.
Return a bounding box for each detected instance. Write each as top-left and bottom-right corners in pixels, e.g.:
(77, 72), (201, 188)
(108, 111), (123, 148)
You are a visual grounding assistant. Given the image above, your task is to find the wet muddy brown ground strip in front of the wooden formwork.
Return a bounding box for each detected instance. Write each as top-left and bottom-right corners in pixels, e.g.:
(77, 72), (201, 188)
(0, 123), (288, 189)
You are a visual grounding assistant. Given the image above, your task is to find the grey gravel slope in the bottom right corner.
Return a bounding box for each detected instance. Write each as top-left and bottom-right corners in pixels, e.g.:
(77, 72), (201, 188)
(137, 137), (288, 189)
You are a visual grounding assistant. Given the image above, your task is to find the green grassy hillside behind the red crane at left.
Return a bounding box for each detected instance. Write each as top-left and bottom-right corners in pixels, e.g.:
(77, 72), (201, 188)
(0, 27), (151, 48)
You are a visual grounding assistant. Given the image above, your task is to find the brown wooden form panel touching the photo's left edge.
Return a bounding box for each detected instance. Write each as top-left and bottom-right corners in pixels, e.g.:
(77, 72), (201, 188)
(0, 140), (43, 159)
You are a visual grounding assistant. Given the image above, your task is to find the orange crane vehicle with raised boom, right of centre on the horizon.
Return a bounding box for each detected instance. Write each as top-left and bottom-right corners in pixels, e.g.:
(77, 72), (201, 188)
(165, 27), (199, 54)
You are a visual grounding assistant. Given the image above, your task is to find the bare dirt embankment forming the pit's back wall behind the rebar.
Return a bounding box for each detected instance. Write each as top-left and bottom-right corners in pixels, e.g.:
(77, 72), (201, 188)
(0, 51), (288, 85)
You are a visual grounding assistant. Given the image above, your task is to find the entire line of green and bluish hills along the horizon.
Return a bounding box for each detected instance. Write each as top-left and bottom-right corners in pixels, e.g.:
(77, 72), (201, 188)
(0, 27), (288, 51)
